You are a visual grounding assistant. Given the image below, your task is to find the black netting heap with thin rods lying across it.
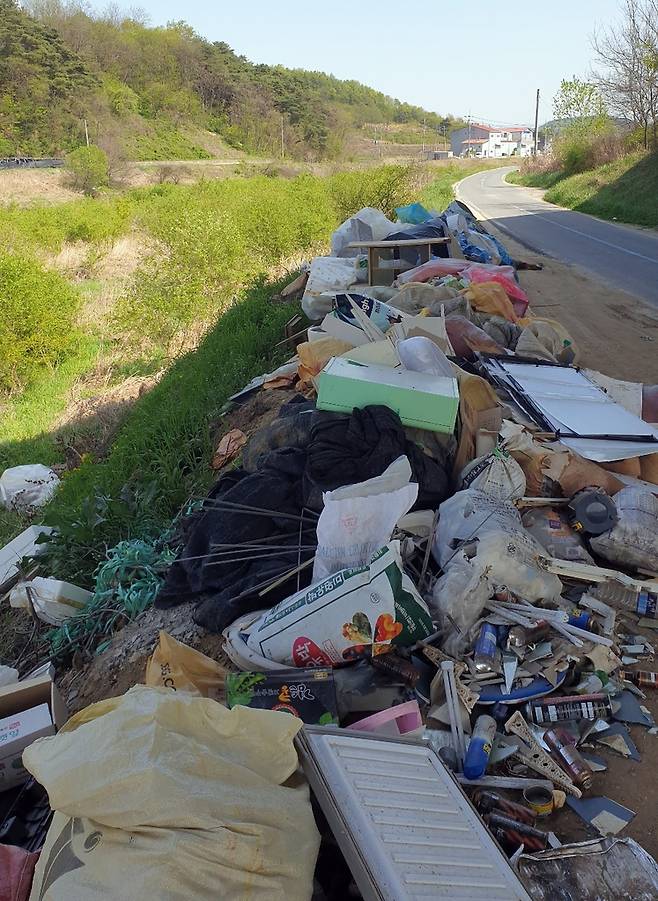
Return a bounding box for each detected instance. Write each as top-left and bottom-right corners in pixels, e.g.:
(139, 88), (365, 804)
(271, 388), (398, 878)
(155, 404), (448, 632)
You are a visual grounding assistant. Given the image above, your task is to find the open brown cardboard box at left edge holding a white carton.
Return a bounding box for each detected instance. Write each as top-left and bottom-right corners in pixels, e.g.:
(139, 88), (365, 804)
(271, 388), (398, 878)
(0, 673), (68, 791)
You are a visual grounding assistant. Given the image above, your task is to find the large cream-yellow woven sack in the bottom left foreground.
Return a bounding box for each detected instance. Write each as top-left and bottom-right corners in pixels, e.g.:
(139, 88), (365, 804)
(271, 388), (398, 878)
(24, 685), (319, 901)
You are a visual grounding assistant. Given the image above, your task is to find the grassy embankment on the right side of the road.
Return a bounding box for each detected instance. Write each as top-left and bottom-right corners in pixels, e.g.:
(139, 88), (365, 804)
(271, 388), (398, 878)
(507, 152), (658, 228)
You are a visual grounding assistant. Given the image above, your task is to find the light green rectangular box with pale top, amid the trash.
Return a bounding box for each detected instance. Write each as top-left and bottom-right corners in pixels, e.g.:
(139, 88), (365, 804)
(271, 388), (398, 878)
(317, 357), (459, 433)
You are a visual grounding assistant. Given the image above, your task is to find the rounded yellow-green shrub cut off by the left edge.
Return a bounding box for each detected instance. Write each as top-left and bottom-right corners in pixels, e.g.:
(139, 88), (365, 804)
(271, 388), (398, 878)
(0, 254), (78, 392)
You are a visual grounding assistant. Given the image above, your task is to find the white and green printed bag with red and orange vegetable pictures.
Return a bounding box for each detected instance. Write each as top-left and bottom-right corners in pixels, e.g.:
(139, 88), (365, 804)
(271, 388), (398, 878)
(247, 541), (432, 666)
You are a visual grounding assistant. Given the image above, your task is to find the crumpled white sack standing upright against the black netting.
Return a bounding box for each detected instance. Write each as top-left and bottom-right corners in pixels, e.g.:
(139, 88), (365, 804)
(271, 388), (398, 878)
(313, 456), (418, 582)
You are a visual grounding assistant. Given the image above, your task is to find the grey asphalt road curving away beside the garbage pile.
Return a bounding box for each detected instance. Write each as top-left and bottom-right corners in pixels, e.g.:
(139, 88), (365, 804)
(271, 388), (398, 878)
(457, 167), (658, 307)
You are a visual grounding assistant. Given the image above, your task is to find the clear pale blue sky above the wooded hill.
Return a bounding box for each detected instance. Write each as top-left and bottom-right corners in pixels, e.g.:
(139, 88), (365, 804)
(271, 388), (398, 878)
(93, 0), (621, 124)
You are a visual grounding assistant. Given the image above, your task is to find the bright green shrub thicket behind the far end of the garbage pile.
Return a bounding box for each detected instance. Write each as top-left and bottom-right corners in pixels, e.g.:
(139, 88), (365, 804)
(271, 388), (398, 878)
(116, 166), (417, 343)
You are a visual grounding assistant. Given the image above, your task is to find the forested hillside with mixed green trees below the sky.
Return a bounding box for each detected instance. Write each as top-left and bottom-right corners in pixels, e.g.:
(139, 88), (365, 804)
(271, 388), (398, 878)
(0, 0), (462, 159)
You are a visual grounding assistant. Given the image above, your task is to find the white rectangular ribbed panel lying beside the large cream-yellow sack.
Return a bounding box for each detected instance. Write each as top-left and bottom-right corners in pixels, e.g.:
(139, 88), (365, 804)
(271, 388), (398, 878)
(305, 729), (529, 901)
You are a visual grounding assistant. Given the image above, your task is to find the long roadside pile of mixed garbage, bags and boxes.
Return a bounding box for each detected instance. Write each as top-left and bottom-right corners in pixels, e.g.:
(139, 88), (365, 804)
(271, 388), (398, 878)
(0, 202), (658, 901)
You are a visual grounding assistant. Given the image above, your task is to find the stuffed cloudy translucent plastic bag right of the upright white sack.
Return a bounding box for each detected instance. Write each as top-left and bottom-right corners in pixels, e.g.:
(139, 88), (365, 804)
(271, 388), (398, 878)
(432, 488), (562, 601)
